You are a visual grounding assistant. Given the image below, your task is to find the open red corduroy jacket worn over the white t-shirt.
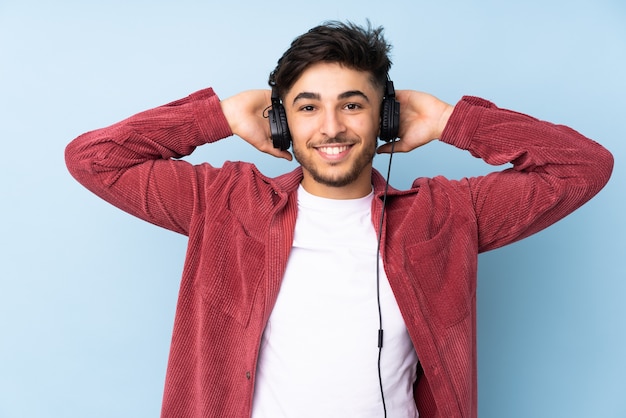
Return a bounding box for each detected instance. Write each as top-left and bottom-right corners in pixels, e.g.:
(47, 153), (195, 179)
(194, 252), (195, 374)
(66, 89), (613, 418)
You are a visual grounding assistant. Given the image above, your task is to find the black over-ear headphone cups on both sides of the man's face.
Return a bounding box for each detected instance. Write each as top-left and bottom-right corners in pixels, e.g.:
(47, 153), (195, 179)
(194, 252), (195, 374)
(267, 79), (400, 150)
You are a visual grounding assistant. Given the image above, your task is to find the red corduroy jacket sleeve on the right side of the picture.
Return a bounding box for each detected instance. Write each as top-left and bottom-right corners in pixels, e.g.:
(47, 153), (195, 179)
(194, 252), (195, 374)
(441, 96), (613, 252)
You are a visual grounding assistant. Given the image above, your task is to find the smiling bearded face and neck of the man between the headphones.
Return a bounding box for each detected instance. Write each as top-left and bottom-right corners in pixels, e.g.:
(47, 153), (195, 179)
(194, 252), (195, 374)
(283, 63), (382, 199)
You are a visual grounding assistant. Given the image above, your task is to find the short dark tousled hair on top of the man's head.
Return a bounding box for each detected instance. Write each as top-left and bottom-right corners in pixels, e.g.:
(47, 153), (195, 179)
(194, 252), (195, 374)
(269, 21), (391, 97)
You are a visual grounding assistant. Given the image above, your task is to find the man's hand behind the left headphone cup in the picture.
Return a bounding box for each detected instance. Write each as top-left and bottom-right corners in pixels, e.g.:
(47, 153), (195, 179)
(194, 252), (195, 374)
(221, 90), (292, 161)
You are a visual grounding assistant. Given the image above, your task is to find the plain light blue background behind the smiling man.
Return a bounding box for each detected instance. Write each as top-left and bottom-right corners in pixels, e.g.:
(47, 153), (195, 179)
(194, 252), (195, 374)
(0, 0), (626, 418)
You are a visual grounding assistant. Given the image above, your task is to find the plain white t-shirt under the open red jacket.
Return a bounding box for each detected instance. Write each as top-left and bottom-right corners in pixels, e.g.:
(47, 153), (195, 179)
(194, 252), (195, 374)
(252, 187), (418, 418)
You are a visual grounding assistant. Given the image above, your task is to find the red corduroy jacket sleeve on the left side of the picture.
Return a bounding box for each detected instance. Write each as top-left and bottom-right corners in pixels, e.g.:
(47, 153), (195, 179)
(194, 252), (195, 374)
(65, 89), (232, 234)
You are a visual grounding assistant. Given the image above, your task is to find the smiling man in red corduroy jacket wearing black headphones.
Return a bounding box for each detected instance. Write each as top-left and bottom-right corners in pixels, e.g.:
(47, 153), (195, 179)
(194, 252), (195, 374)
(66, 22), (613, 418)
